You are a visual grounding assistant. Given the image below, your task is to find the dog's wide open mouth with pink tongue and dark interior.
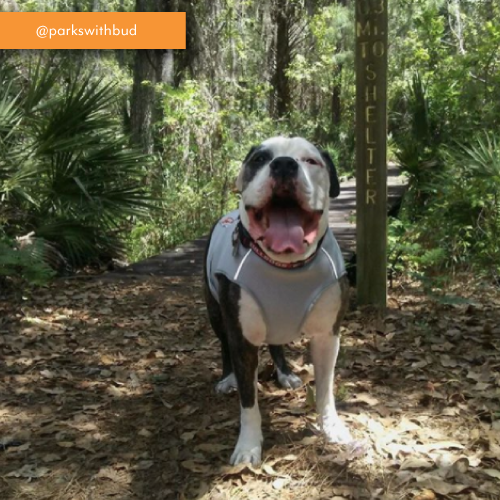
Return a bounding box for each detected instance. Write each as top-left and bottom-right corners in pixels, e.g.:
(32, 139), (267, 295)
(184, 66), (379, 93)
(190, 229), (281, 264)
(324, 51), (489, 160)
(246, 197), (323, 254)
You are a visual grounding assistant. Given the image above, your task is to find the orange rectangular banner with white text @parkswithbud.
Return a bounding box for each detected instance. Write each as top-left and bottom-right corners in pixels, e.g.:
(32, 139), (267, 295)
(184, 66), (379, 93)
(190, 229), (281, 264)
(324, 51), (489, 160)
(0, 12), (186, 49)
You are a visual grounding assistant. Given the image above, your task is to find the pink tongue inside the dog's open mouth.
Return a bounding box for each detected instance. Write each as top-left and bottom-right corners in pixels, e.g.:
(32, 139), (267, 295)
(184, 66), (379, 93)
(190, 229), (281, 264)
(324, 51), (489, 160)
(264, 208), (305, 253)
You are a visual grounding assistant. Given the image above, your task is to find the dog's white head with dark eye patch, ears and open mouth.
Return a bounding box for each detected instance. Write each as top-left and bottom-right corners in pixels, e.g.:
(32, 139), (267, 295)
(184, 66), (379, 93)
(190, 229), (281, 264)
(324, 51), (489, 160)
(236, 137), (340, 263)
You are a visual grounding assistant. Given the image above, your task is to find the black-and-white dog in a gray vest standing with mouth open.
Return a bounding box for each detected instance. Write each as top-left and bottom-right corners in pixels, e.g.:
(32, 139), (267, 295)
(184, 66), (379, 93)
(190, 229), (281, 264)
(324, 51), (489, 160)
(204, 137), (351, 465)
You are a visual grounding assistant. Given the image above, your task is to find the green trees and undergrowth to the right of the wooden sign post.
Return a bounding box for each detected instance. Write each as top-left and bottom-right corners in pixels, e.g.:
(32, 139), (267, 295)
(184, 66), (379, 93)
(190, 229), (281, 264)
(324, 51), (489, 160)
(389, 2), (500, 290)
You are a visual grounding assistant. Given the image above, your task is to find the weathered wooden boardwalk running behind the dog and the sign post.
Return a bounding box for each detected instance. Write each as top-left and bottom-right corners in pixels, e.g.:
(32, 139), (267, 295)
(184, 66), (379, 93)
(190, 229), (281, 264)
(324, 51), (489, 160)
(115, 166), (406, 278)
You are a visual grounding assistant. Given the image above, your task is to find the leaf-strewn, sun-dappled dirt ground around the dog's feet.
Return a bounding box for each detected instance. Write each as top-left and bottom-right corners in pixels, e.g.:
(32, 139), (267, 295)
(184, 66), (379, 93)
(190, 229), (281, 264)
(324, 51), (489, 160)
(0, 278), (500, 500)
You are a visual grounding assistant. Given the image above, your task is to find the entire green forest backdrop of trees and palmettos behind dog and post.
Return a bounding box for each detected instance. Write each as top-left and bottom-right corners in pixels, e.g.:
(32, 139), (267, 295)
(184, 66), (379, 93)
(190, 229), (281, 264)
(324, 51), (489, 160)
(0, 0), (500, 290)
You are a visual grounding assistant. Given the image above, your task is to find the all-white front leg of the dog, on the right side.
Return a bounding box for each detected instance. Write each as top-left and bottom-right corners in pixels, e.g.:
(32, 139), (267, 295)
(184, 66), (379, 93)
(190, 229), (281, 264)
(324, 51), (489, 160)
(311, 332), (352, 443)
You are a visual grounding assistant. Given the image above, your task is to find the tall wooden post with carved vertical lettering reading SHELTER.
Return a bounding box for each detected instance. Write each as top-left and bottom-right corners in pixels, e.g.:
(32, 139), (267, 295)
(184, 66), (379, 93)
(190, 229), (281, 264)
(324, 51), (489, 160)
(355, 0), (388, 309)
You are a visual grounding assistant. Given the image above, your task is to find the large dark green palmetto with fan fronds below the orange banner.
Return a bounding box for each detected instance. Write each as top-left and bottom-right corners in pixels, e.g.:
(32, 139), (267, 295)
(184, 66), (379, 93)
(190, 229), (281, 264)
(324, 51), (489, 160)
(0, 61), (151, 278)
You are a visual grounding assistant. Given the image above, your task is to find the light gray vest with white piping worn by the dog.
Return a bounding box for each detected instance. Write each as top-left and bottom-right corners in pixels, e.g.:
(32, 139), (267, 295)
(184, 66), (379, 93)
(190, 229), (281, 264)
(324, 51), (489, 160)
(207, 210), (346, 344)
